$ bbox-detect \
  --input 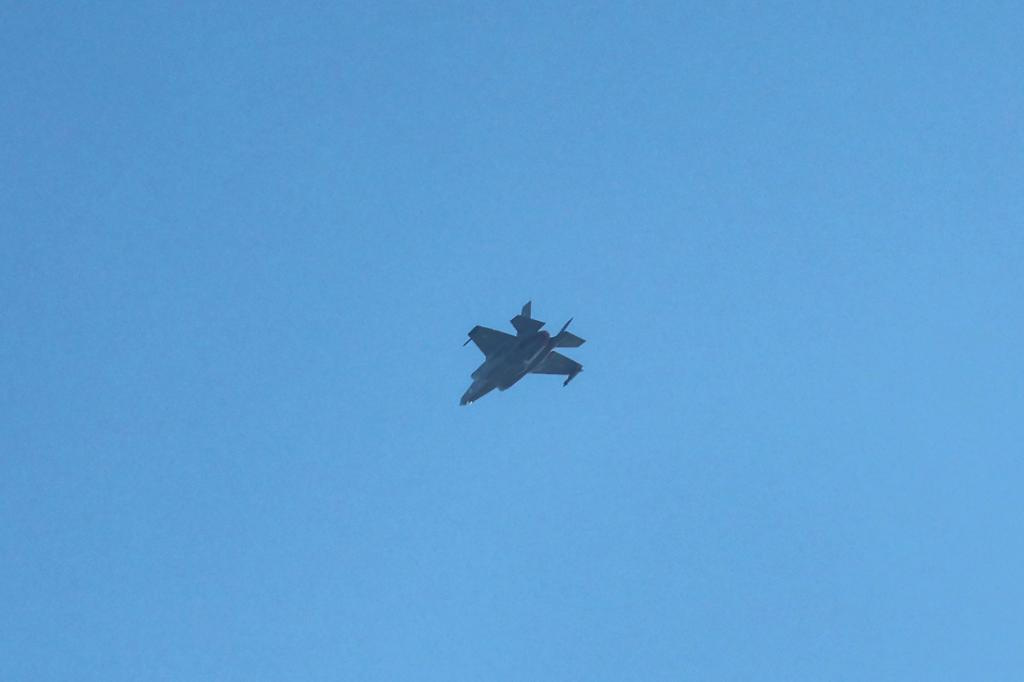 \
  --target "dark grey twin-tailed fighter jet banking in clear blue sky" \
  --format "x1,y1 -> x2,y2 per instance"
459,301 -> 585,404
